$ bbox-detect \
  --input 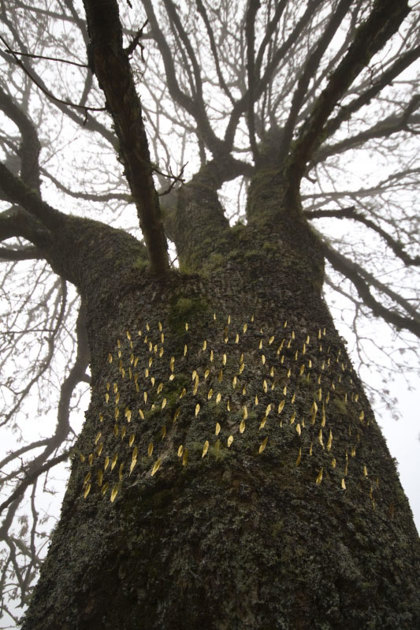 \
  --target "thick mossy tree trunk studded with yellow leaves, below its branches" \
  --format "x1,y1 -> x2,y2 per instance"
23,174 -> 420,630
